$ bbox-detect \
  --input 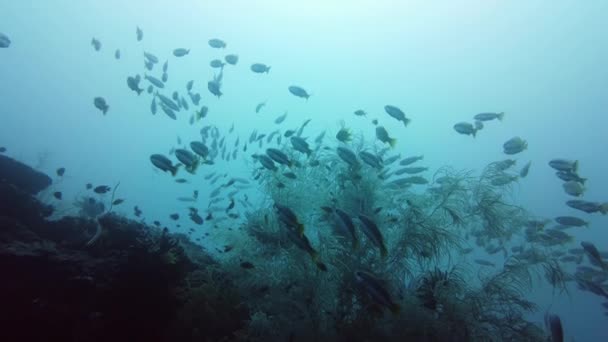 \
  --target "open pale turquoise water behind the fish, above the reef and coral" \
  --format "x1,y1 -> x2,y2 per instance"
0,0 -> 608,341
